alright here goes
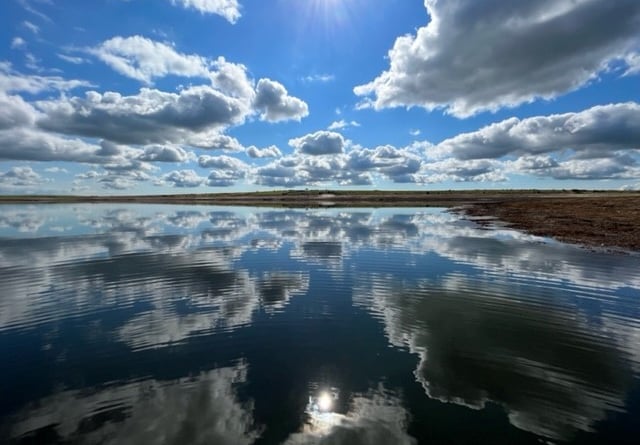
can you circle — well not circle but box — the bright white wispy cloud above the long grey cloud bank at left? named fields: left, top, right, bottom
left=89, top=35, right=209, bottom=84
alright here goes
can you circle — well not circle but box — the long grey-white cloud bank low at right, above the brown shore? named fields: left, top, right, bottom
left=422, top=102, right=640, bottom=182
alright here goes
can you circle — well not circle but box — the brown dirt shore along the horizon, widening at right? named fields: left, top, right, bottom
left=0, top=190, right=640, bottom=251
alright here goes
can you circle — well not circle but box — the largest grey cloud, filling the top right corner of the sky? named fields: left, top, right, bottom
left=354, top=0, right=640, bottom=117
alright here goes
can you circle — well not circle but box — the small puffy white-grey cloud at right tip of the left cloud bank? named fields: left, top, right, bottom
left=254, top=79, right=309, bottom=122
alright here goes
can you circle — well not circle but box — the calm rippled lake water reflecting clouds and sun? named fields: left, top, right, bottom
left=0, top=205, right=640, bottom=444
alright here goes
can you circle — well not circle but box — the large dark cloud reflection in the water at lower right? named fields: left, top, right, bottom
left=355, top=276, right=632, bottom=439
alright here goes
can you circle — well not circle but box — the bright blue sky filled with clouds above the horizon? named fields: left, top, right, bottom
left=0, top=0, right=640, bottom=194
